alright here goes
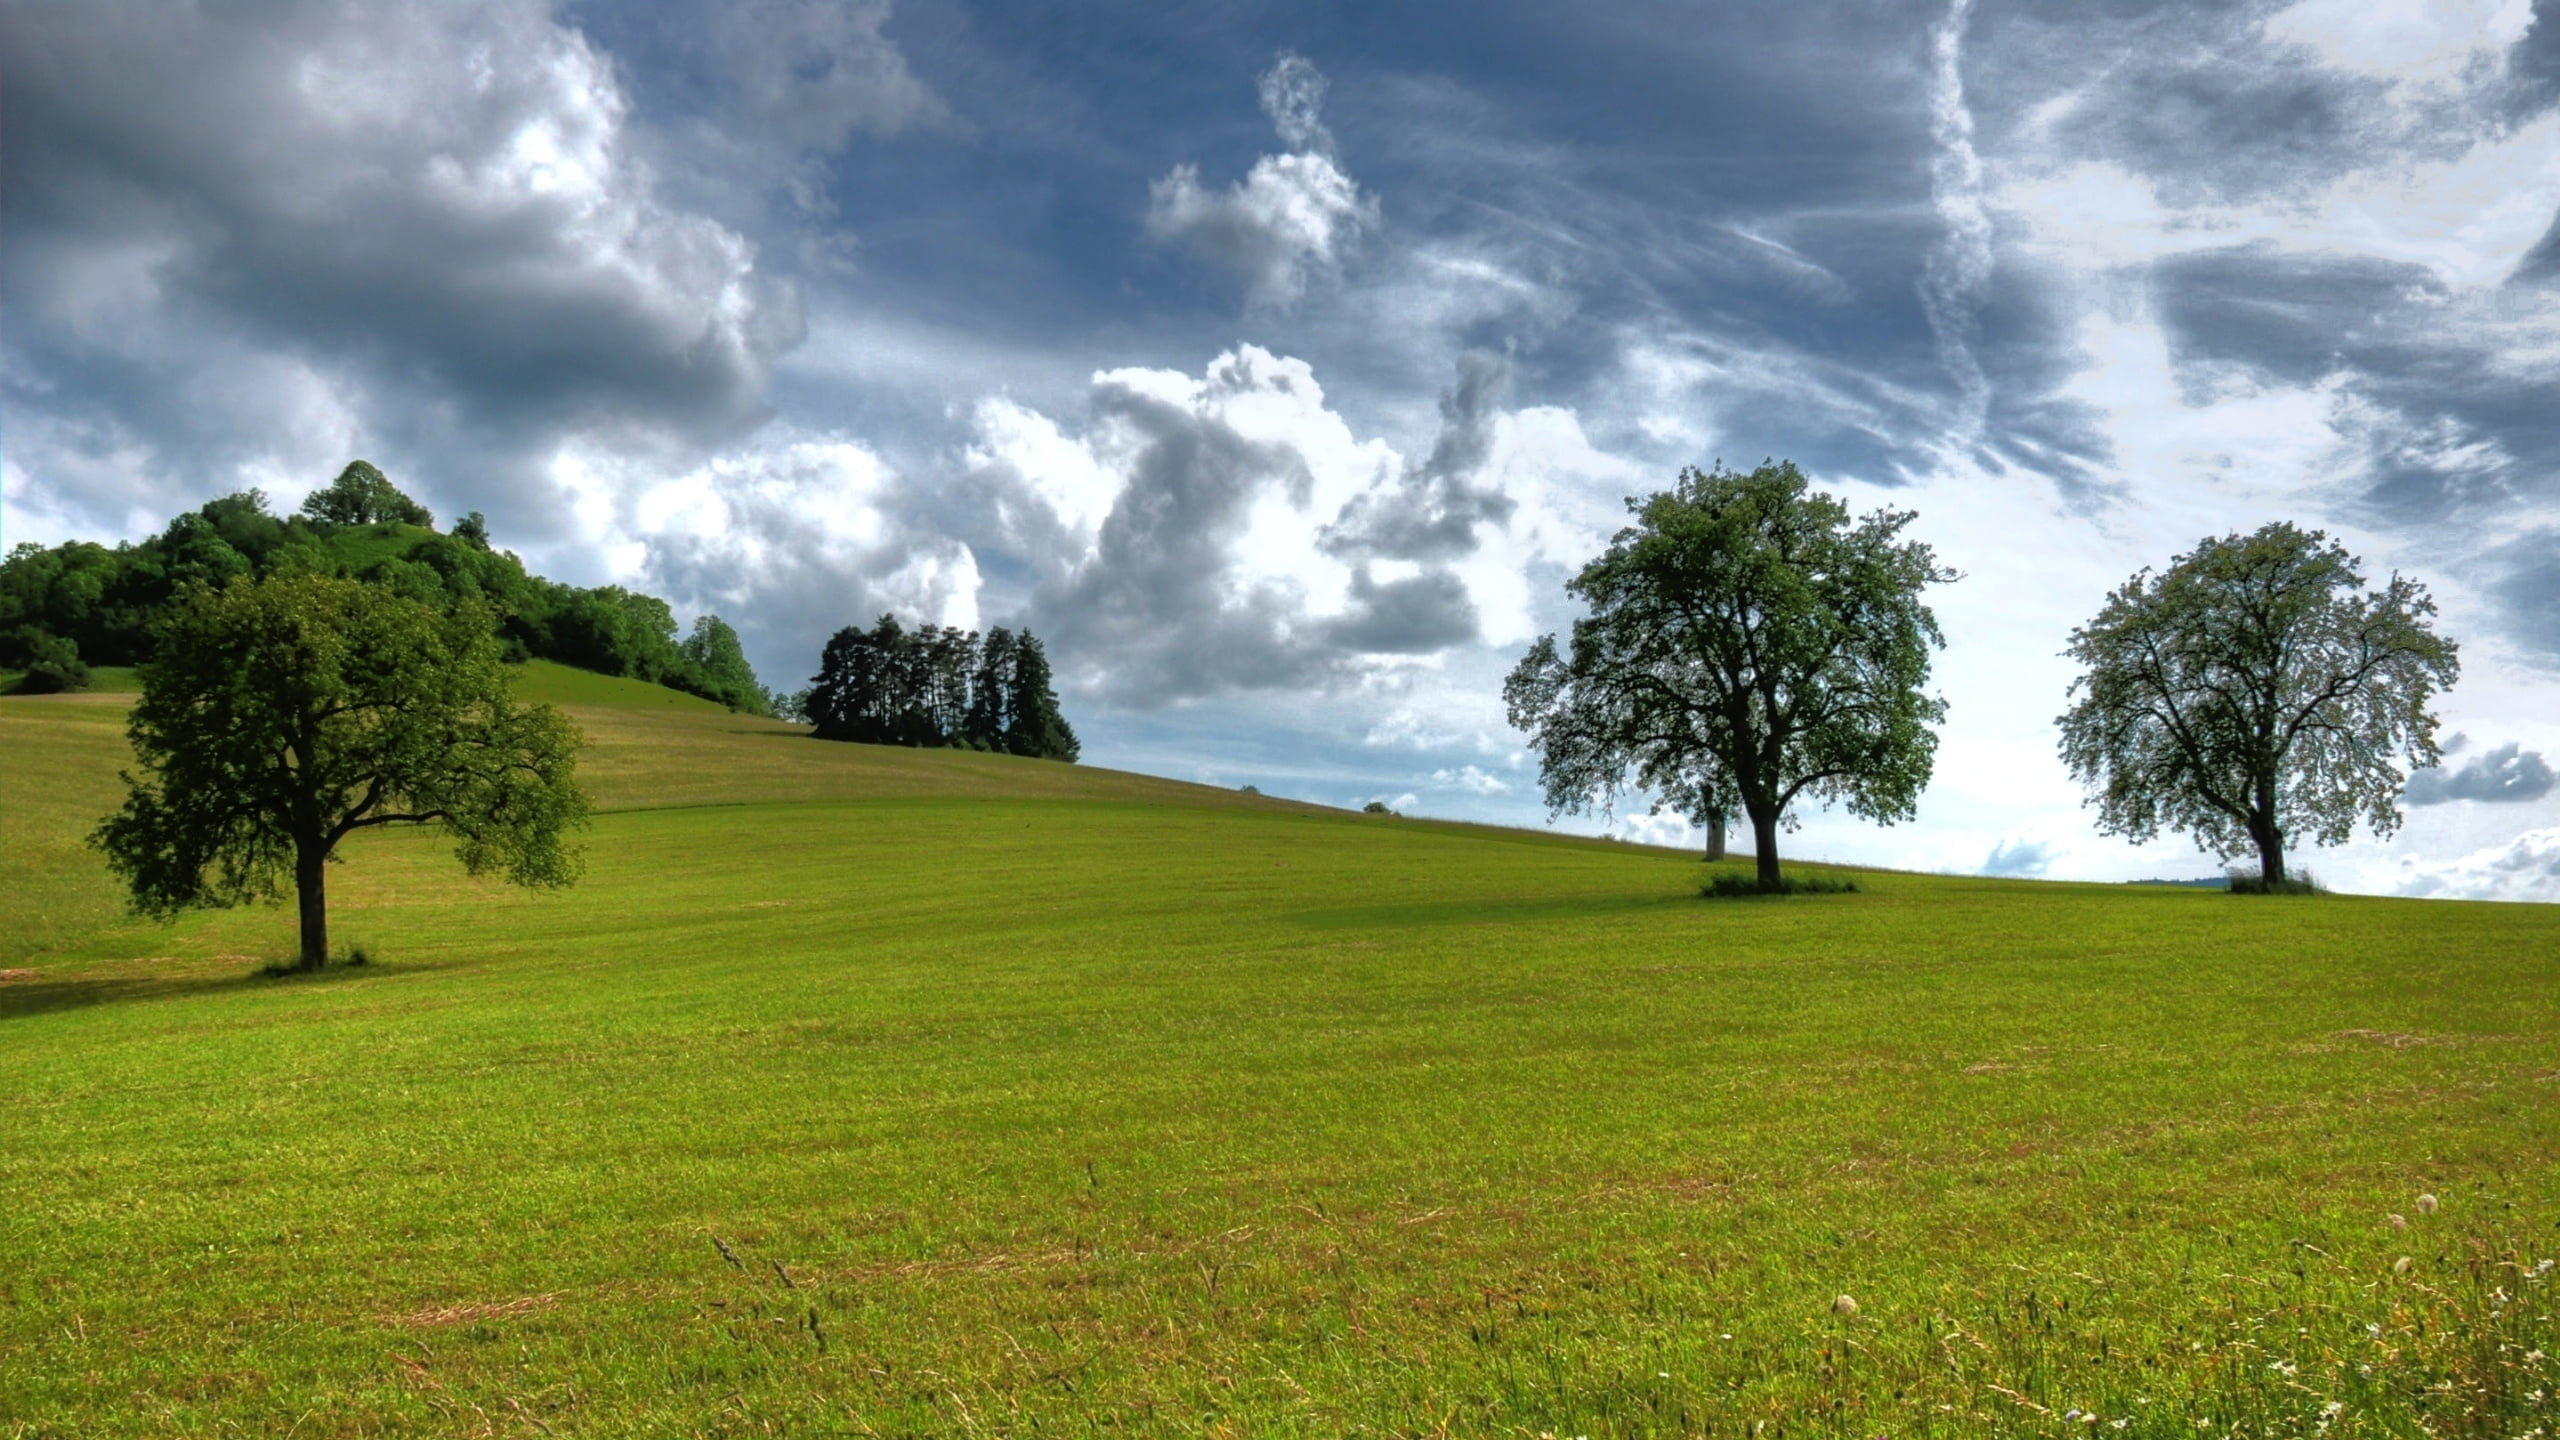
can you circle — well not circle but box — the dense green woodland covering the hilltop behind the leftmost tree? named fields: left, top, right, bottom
left=0, top=461, right=773, bottom=715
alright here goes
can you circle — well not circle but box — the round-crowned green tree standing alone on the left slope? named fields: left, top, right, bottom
left=90, top=574, right=586, bottom=969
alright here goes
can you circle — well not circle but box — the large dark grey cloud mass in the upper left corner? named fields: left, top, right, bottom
left=0, top=0, right=801, bottom=523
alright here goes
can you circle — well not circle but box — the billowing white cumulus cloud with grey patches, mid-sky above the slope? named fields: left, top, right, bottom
left=965, top=346, right=1626, bottom=707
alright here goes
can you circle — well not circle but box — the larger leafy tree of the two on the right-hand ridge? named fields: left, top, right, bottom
left=1503, top=464, right=1956, bottom=889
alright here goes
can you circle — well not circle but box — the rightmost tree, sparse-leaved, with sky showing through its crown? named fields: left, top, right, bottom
left=2061, top=520, right=2460, bottom=889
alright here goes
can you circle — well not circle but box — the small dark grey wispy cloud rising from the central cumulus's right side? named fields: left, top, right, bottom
left=1324, top=351, right=1518, bottom=561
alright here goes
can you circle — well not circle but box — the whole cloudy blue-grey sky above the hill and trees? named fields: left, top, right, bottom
left=0, top=0, right=2560, bottom=899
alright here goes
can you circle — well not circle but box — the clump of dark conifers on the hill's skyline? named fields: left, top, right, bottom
left=799, top=615, right=1078, bottom=761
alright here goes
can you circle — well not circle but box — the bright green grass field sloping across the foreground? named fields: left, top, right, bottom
left=0, top=666, right=2560, bottom=1437
